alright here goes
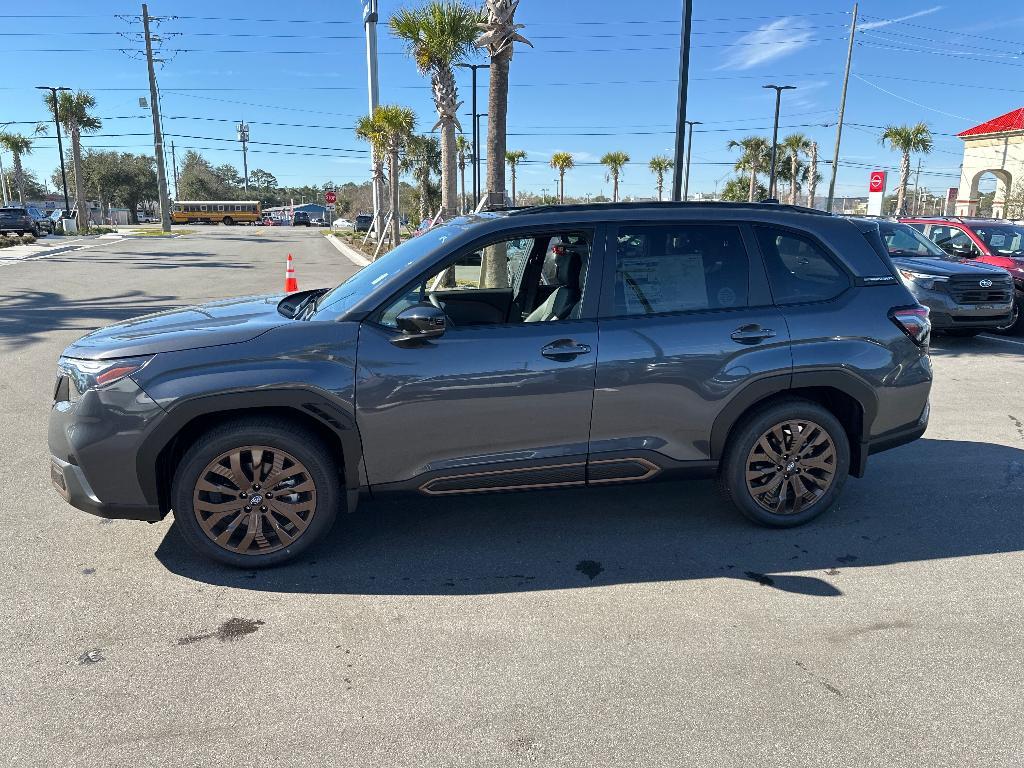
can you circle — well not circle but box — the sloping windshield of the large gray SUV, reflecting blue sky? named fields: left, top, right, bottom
left=314, top=220, right=469, bottom=319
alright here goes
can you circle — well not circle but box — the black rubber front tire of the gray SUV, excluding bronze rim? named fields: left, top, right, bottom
left=171, top=418, right=343, bottom=568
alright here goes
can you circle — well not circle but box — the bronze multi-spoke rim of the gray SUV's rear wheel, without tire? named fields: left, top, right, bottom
left=746, top=419, right=836, bottom=515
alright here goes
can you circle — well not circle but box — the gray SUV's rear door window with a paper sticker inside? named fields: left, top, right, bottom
left=612, top=224, right=750, bottom=315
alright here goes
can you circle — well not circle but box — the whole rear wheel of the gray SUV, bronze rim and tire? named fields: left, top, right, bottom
left=719, top=397, right=850, bottom=527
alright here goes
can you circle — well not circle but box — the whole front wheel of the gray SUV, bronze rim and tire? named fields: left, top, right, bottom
left=171, top=419, right=341, bottom=568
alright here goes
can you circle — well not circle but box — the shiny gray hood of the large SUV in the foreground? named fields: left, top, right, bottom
left=65, top=294, right=295, bottom=359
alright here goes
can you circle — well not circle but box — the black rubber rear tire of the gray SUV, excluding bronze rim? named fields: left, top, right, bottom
left=718, top=397, right=850, bottom=527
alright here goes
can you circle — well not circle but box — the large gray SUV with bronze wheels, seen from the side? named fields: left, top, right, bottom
left=49, top=203, right=932, bottom=567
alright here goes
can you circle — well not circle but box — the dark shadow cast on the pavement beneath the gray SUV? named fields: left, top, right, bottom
left=156, top=442, right=1024, bottom=597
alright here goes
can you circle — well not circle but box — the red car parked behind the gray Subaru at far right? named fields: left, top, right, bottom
left=900, top=216, right=1024, bottom=334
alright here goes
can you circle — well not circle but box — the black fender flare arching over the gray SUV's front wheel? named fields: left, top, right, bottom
left=136, top=387, right=362, bottom=505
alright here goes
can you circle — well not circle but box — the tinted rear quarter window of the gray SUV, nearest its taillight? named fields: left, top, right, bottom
left=755, top=226, right=850, bottom=304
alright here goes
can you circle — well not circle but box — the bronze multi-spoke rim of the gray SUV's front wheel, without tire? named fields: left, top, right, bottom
left=193, top=445, right=316, bottom=555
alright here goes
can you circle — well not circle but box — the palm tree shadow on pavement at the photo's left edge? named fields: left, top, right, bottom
left=0, top=291, right=183, bottom=347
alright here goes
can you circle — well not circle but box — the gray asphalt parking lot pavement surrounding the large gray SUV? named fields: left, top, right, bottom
left=0, top=227, right=1024, bottom=766
